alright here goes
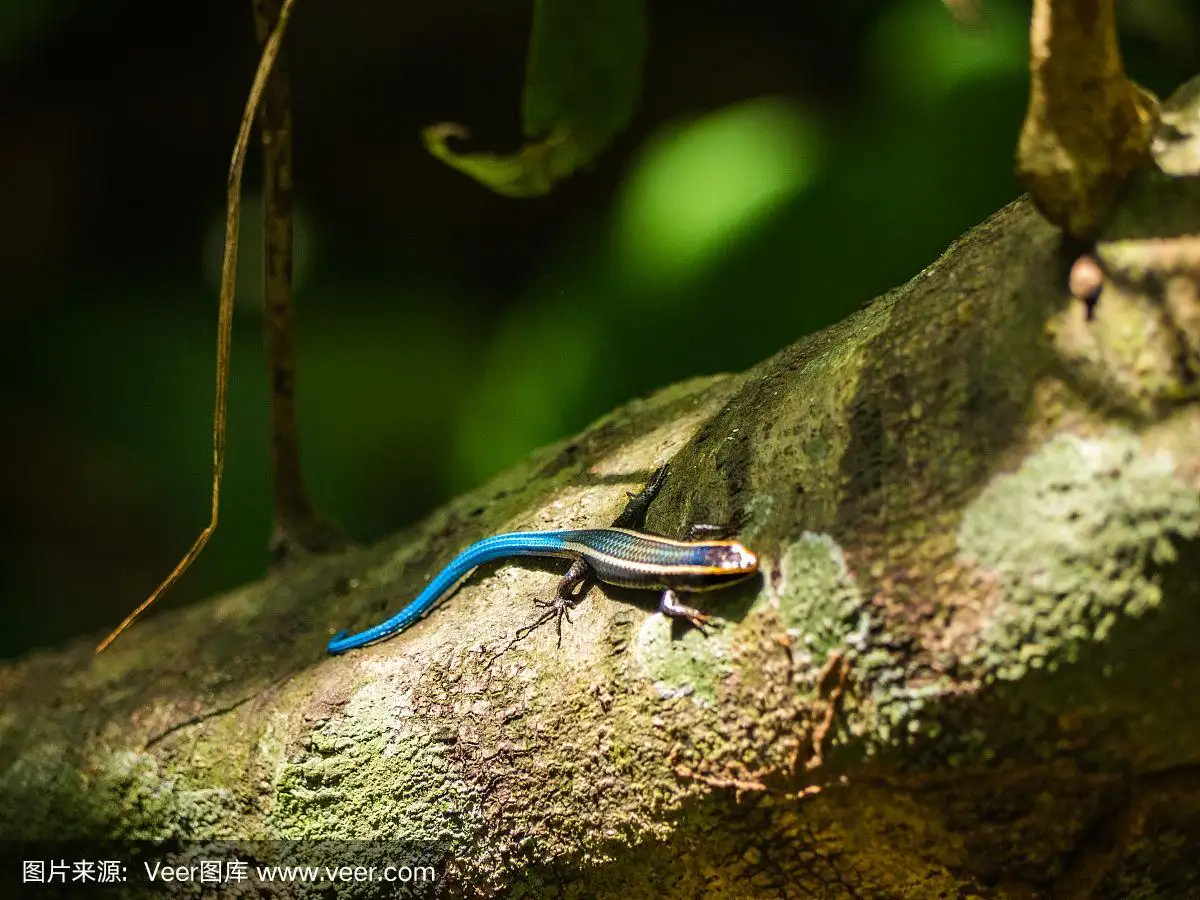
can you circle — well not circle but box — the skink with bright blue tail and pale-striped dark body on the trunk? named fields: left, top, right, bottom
left=329, top=466, right=758, bottom=653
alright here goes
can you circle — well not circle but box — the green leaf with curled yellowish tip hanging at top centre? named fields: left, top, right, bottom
left=421, top=0, right=646, bottom=197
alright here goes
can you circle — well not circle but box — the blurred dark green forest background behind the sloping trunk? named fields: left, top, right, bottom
left=0, top=0, right=1200, bottom=655
